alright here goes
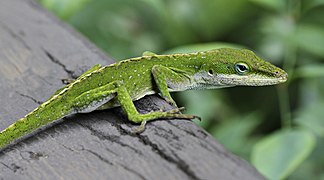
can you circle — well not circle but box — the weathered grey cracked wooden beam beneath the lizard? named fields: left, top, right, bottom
left=0, top=0, right=263, bottom=180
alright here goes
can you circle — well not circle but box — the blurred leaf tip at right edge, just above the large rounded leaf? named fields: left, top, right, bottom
left=295, top=102, right=324, bottom=137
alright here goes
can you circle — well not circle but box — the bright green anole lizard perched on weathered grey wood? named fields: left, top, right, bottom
left=0, top=48, right=287, bottom=149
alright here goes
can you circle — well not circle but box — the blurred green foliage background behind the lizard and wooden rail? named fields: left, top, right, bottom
left=39, top=0, right=324, bottom=179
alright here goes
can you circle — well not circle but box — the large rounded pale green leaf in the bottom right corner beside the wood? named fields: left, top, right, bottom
left=251, top=129, right=315, bottom=179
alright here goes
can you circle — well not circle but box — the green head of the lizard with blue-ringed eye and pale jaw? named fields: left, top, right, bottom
left=197, top=48, right=288, bottom=88
